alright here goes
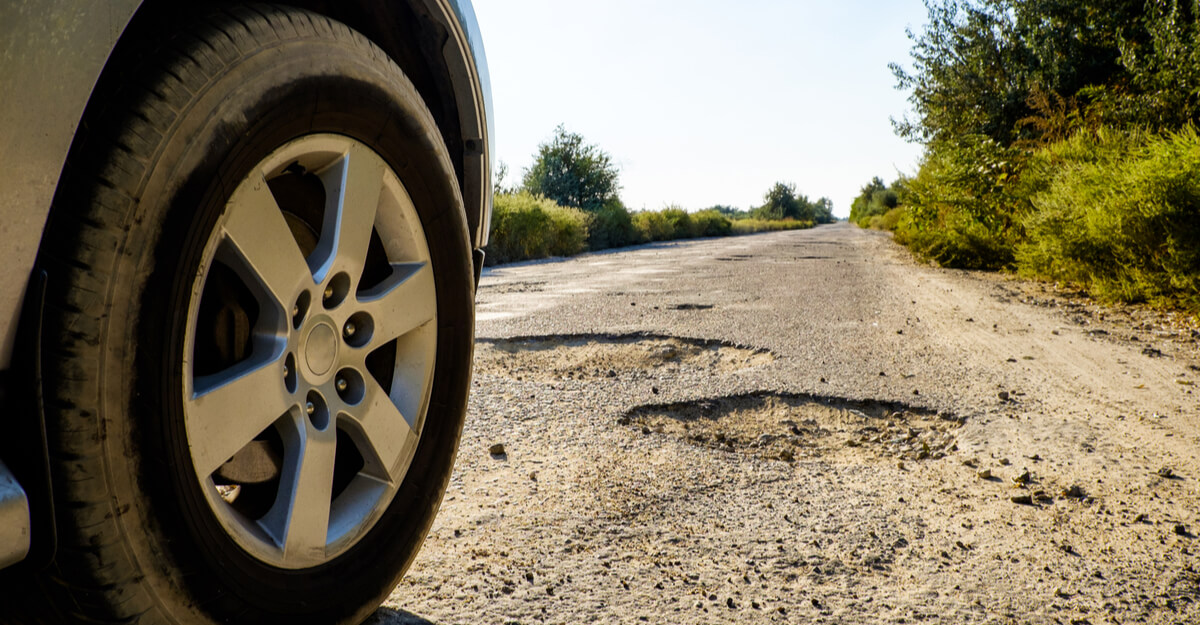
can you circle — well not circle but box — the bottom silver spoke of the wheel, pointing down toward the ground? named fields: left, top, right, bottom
left=263, top=414, right=337, bottom=566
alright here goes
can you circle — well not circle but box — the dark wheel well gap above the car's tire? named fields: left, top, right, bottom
left=109, top=0, right=474, bottom=197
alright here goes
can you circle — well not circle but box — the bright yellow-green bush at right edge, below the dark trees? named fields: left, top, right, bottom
left=1016, top=128, right=1200, bottom=310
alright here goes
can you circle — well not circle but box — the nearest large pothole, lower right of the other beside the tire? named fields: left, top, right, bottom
left=619, top=392, right=962, bottom=462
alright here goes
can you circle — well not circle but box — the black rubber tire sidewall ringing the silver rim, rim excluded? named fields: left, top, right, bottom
left=101, top=28, right=473, bottom=623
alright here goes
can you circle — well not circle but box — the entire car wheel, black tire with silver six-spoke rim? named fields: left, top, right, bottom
left=25, top=5, right=474, bottom=624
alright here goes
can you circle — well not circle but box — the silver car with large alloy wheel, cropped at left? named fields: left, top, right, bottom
left=0, top=0, right=492, bottom=624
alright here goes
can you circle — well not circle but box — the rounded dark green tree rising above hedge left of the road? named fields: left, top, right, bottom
left=523, top=125, right=620, bottom=212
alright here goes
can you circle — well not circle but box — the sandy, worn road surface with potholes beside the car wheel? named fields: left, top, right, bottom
left=371, top=226, right=1200, bottom=625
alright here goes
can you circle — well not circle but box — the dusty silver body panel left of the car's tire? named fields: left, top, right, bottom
left=0, top=0, right=139, bottom=369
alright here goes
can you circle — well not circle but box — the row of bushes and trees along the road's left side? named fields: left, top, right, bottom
left=486, top=126, right=834, bottom=264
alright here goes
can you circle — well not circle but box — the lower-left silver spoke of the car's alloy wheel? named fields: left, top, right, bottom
left=184, top=357, right=295, bottom=477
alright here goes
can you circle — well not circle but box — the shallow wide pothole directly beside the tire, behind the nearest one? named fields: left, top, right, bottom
left=475, top=333, right=775, bottom=380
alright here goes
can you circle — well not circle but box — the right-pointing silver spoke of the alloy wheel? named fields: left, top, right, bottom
left=359, top=263, right=438, bottom=348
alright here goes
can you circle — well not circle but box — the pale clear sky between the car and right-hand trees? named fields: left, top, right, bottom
left=474, top=0, right=925, bottom=216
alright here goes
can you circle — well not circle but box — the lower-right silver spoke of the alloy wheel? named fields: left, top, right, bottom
left=343, top=379, right=418, bottom=482
